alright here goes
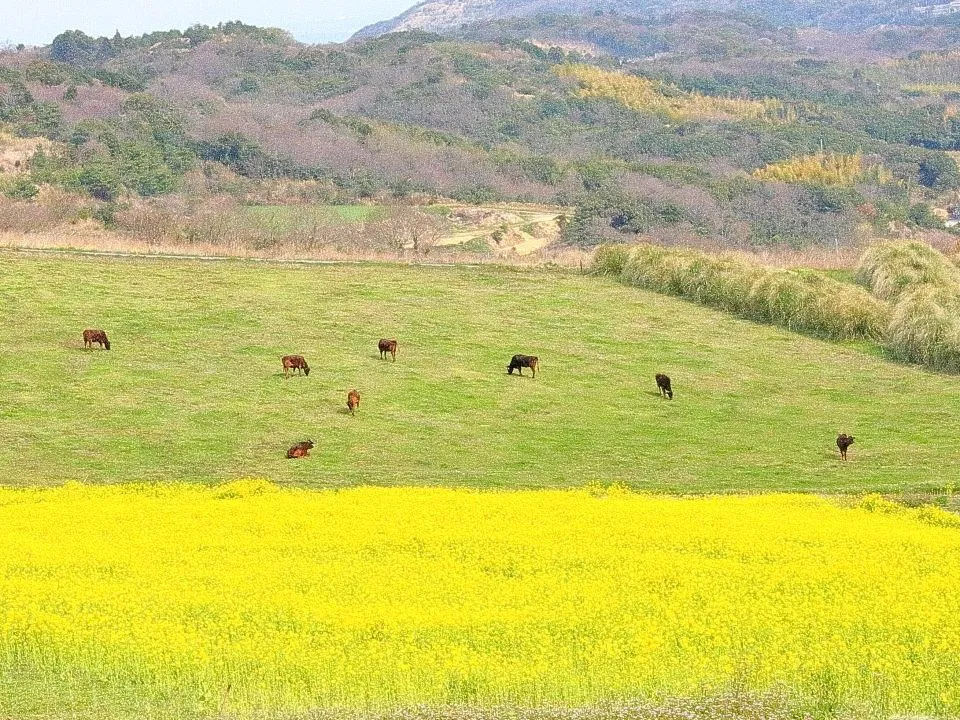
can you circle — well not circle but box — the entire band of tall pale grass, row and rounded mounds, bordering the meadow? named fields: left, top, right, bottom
left=604, top=241, right=960, bottom=373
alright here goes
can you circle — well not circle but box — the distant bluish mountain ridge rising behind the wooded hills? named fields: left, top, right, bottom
left=354, top=0, right=960, bottom=39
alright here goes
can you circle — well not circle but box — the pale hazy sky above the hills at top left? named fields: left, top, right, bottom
left=0, top=0, right=417, bottom=45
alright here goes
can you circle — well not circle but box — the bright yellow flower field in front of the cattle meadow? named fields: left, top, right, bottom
left=0, top=480, right=960, bottom=717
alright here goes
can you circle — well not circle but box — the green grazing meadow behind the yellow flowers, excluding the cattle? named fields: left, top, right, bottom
left=0, top=253, right=960, bottom=493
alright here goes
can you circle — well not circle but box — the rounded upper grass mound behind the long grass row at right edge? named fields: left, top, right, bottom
left=855, top=241, right=960, bottom=302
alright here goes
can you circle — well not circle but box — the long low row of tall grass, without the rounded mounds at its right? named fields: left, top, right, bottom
left=593, top=245, right=889, bottom=339
